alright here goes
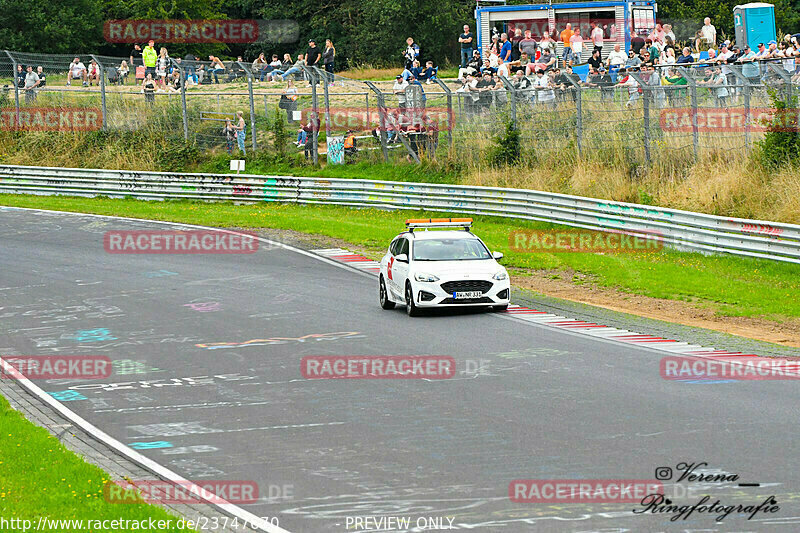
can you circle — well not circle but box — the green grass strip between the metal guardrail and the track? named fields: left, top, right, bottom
left=0, top=195, right=800, bottom=322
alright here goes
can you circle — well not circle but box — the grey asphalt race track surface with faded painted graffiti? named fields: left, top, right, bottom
left=0, top=208, right=800, bottom=532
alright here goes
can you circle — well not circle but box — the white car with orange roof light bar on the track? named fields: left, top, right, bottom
left=379, top=218, right=511, bottom=316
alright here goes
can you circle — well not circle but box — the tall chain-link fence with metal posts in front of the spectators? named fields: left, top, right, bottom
left=0, top=51, right=799, bottom=164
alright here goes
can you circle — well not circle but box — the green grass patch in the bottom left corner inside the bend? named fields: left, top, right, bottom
left=0, top=390, right=187, bottom=532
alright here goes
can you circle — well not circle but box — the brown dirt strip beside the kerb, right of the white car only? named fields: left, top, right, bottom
left=511, top=271, right=800, bottom=348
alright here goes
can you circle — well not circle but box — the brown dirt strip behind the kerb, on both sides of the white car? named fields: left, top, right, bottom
left=245, top=229, right=800, bottom=348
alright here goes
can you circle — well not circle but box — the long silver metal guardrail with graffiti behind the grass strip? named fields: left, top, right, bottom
left=0, top=165, right=800, bottom=263
